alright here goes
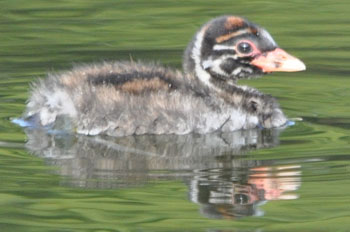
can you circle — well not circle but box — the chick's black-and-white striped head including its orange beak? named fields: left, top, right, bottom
left=183, top=16, right=305, bottom=86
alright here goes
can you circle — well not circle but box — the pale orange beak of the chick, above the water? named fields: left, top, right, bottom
left=250, top=48, right=306, bottom=72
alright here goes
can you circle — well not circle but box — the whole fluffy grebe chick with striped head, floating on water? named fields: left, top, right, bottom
left=24, top=16, right=305, bottom=136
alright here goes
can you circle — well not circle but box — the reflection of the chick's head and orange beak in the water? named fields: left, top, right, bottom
left=190, top=161, right=301, bottom=219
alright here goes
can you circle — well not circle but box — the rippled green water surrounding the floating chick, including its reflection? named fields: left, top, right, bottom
left=0, top=0, right=350, bottom=232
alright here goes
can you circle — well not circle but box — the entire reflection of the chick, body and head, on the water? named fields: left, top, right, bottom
left=26, top=130, right=300, bottom=219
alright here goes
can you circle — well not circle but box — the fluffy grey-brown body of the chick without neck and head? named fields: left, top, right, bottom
left=26, top=62, right=241, bottom=136
